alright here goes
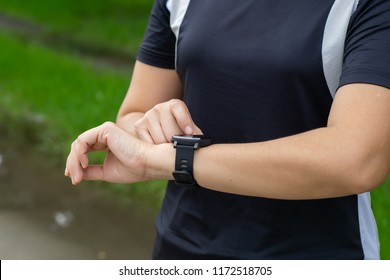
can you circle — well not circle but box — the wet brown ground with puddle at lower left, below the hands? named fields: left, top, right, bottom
left=0, top=138, right=157, bottom=259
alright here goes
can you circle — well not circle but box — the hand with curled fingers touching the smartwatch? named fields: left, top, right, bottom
left=135, top=99, right=203, bottom=144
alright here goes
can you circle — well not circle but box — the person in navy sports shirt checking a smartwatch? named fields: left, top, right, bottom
left=65, top=0, right=390, bottom=259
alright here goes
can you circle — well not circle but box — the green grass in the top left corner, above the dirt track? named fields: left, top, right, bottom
left=0, top=0, right=153, bottom=55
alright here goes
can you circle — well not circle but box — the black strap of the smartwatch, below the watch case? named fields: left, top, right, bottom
left=172, top=144, right=196, bottom=186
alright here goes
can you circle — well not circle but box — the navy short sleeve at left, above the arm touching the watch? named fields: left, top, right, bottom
left=137, top=0, right=176, bottom=69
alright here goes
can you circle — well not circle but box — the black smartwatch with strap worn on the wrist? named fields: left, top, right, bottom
left=171, top=135, right=211, bottom=186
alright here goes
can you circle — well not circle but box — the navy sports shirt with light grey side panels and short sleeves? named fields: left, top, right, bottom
left=138, top=0, right=390, bottom=259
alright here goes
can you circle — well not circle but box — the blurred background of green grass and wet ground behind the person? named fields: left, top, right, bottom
left=0, top=0, right=390, bottom=259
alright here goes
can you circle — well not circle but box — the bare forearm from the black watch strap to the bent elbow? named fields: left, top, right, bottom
left=194, top=128, right=387, bottom=199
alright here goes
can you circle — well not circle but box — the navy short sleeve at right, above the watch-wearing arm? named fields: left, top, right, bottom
left=340, top=0, right=390, bottom=88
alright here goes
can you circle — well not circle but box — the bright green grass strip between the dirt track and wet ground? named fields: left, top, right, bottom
left=0, top=31, right=125, bottom=137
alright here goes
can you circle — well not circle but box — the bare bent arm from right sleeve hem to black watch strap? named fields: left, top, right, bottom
left=194, top=84, right=390, bottom=199
